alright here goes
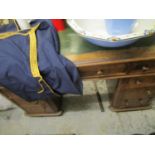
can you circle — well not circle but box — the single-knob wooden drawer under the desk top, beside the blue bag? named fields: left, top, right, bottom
left=79, top=64, right=126, bottom=78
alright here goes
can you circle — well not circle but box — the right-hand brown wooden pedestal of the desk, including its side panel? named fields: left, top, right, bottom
left=107, top=78, right=155, bottom=112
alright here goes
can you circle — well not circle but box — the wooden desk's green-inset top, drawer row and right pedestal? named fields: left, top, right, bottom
left=59, top=29, right=155, bottom=111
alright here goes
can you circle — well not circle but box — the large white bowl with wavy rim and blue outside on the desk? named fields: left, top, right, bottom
left=67, top=19, right=155, bottom=47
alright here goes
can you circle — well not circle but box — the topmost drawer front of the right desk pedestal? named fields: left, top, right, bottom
left=120, top=76, right=155, bottom=90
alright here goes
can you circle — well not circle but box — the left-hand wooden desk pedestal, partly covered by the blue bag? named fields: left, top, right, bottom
left=0, top=87, right=62, bottom=117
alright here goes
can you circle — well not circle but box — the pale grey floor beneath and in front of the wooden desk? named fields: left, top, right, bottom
left=0, top=80, right=155, bottom=135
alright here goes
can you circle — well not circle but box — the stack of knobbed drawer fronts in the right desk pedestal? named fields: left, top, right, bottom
left=111, top=77, right=155, bottom=109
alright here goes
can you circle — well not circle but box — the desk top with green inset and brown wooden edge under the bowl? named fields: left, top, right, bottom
left=59, top=28, right=155, bottom=66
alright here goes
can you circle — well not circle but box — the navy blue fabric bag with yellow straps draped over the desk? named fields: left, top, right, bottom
left=0, top=20, right=82, bottom=101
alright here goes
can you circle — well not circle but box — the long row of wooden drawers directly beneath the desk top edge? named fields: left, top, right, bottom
left=79, top=61, right=155, bottom=79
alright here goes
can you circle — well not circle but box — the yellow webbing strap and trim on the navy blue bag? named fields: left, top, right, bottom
left=0, top=25, right=59, bottom=96
